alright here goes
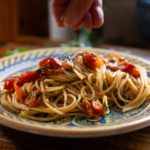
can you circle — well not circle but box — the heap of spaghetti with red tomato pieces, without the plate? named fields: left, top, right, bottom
left=0, top=51, right=150, bottom=121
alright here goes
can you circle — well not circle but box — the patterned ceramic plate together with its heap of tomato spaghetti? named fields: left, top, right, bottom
left=0, top=48, right=150, bottom=137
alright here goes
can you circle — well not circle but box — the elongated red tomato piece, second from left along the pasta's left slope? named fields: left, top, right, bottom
left=20, top=71, right=40, bottom=85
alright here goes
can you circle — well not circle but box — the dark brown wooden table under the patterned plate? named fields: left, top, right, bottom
left=0, top=44, right=150, bottom=150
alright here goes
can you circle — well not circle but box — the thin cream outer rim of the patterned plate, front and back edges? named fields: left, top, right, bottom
left=0, top=47, right=150, bottom=137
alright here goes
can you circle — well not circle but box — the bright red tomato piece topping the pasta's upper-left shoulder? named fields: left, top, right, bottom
left=39, top=57, right=62, bottom=69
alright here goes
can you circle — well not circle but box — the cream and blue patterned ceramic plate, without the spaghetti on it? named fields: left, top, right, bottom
left=0, top=48, right=150, bottom=137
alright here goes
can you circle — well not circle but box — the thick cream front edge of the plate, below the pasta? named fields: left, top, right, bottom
left=0, top=114, right=150, bottom=138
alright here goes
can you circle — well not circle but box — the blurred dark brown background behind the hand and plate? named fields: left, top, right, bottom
left=0, top=0, right=150, bottom=55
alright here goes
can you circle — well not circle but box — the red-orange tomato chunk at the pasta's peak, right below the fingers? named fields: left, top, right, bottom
left=83, top=53, right=104, bottom=70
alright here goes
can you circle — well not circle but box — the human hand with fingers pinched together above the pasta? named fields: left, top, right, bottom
left=51, top=0, right=104, bottom=29
